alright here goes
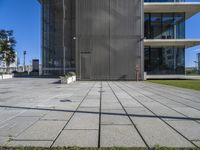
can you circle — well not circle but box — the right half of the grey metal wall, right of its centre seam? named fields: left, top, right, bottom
left=110, top=0, right=141, bottom=80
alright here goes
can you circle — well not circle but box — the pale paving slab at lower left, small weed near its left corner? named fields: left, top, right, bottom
left=14, top=121, right=66, bottom=141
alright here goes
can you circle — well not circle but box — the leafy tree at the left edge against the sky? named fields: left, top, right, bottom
left=0, top=30, right=16, bottom=72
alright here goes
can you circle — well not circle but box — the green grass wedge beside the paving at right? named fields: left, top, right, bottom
left=148, top=80, right=200, bottom=91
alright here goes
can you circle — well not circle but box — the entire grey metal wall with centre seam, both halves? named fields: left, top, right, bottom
left=76, top=0, right=143, bottom=80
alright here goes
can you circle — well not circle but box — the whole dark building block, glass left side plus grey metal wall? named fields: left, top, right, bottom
left=42, top=0, right=143, bottom=80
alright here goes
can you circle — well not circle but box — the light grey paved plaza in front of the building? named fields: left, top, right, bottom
left=0, top=78, right=200, bottom=147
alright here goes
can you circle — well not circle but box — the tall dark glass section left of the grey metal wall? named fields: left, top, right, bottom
left=42, top=0, right=75, bottom=75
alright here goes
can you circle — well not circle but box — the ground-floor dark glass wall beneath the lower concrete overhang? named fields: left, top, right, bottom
left=145, top=47, right=185, bottom=75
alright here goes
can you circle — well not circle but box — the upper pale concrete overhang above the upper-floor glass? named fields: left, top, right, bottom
left=144, top=2, right=200, bottom=19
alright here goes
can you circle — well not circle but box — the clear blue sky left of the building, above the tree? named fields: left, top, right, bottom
left=0, top=0, right=41, bottom=64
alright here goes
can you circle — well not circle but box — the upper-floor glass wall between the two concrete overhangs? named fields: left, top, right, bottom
left=144, top=13, right=185, bottom=39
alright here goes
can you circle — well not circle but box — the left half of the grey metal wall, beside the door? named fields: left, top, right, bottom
left=76, top=0, right=109, bottom=80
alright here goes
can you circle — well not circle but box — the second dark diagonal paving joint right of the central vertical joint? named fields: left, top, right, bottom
left=114, top=83, right=199, bottom=148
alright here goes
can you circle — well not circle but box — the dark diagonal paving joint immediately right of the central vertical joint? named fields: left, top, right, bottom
left=107, top=82, right=150, bottom=150
